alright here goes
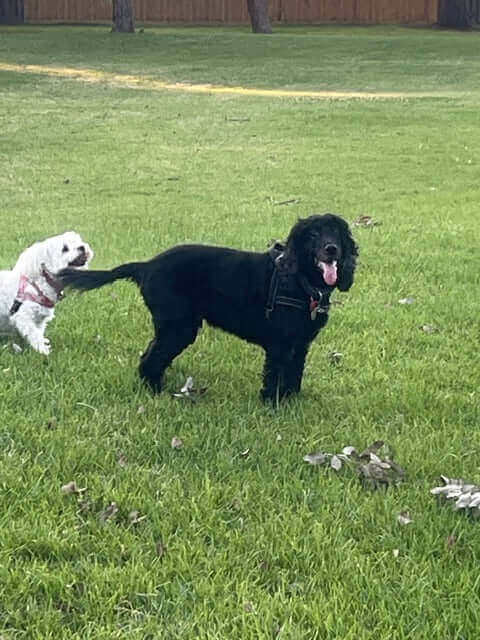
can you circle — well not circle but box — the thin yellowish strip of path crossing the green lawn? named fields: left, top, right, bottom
left=0, top=62, right=461, bottom=100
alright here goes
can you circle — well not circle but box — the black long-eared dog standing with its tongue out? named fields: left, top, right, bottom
left=58, top=214, right=358, bottom=401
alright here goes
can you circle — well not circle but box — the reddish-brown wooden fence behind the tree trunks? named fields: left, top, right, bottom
left=25, top=0, right=438, bottom=24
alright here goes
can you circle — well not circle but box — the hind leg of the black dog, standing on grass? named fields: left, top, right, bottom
left=139, top=325, right=198, bottom=393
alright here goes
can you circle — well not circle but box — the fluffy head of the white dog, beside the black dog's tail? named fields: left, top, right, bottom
left=14, top=231, right=93, bottom=276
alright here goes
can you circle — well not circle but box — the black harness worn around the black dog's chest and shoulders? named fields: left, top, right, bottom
left=265, top=242, right=330, bottom=321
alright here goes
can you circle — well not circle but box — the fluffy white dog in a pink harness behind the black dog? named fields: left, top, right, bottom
left=0, top=231, right=93, bottom=355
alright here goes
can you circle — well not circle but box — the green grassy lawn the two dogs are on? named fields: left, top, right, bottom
left=0, top=27, right=480, bottom=640
